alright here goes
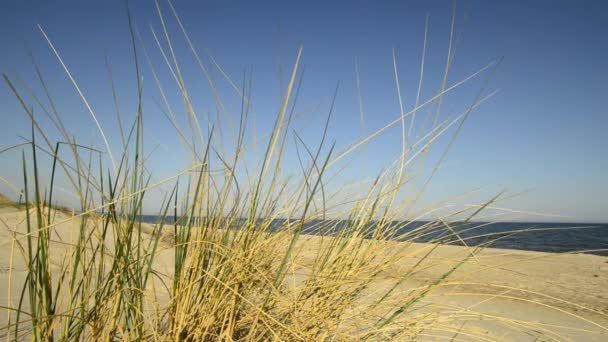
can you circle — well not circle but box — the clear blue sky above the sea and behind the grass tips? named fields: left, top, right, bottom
left=0, top=0, right=608, bottom=222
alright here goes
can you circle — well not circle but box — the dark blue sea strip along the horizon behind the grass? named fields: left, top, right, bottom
left=141, top=215, right=608, bottom=256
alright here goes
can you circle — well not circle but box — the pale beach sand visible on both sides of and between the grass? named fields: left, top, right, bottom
left=0, top=207, right=608, bottom=341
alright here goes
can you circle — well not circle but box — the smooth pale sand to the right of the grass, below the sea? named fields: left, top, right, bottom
left=294, top=236, right=608, bottom=341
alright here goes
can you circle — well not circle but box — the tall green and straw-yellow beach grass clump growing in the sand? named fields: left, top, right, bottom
left=0, top=3, right=604, bottom=341
